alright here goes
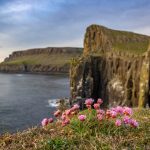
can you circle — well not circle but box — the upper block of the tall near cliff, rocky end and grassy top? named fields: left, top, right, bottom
left=84, top=25, right=150, bottom=54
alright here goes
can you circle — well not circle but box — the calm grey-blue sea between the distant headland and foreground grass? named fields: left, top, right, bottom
left=0, top=74, right=69, bottom=134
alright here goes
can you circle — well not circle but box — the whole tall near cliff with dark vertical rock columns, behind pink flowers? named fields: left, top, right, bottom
left=70, top=25, right=150, bottom=107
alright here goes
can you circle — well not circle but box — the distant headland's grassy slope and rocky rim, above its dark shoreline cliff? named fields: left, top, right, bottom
left=2, top=47, right=82, bottom=66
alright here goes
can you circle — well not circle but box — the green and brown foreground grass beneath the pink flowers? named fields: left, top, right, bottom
left=0, top=109, right=150, bottom=150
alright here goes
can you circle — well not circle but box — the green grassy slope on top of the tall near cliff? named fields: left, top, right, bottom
left=89, top=25, right=150, bottom=54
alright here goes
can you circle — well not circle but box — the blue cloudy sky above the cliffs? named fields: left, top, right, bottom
left=0, top=0, right=150, bottom=61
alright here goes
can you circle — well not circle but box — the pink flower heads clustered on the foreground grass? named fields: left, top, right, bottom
left=41, top=98, right=139, bottom=128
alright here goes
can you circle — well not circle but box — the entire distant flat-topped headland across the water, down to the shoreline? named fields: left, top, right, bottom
left=0, top=47, right=82, bottom=73
